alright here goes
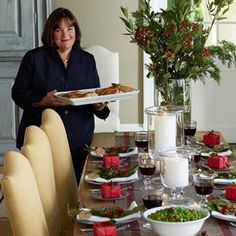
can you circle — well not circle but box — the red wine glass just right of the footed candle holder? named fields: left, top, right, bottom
left=193, top=172, right=214, bottom=207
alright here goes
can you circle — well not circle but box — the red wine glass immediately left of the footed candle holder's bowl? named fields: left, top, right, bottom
left=138, top=152, right=156, bottom=185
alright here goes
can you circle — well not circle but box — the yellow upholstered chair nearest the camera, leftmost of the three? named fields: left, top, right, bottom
left=1, top=151, right=50, bottom=236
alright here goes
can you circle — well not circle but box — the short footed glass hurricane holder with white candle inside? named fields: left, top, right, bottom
left=159, top=147, right=195, bottom=205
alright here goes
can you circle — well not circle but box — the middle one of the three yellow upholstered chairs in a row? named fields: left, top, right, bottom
left=21, top=125, right=62, bottom=236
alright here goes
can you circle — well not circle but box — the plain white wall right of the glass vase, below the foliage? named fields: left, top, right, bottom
left=192, top=68, right=236, bottom=143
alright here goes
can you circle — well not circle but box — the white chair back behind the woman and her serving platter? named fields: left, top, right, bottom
left=84, top=45, right=120, bottom=133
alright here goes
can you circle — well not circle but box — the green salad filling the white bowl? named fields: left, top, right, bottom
left=148, top=207, right=206, bottom=222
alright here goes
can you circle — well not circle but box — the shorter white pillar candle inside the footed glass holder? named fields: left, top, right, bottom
left=165, top=157, right=189, bottom=188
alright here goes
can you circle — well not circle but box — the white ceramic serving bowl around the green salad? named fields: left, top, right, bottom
left=143, top=206, right=210, bottom=236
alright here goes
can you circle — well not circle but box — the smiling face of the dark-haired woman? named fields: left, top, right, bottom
left=53, top=19, right=75, bottom=52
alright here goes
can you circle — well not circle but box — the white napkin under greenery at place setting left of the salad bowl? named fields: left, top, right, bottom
left=76, top=201, right=141, bottom=223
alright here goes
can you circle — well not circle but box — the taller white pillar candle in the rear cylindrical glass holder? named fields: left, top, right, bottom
left=154, top=113, right=177, bottom=153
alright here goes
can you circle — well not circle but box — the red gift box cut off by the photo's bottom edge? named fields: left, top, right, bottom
left=93, top=222, right=117, bottom=236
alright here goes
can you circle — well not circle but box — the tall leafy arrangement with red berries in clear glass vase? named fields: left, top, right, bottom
left=120, top=0, right=236, bottom=118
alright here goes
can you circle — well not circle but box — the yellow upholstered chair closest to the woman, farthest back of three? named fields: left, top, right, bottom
left=41, top=109, right=79, bottom=229
